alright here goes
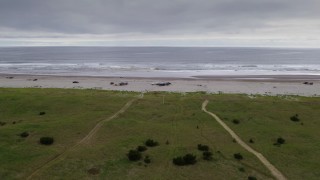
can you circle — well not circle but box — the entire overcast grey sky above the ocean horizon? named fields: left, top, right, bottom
left=0, top=0, right=320, bottom=47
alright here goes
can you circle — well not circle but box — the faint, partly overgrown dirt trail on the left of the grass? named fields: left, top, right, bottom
left=26, top=94, right=143, bottom=180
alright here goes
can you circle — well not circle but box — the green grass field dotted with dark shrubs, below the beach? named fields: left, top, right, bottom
left=0, top=88, right=320, bottom=180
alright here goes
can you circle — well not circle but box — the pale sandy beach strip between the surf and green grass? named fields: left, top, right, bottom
left=0, top=74, right=320, bottom=96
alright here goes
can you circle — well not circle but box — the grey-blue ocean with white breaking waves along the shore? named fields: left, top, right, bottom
left=0, top=47, right=320, bottom=78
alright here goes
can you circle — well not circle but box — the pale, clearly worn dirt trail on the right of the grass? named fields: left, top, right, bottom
left=202, top=100, right=287, bottom=180
